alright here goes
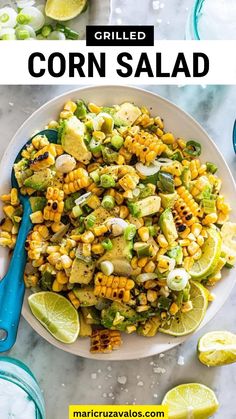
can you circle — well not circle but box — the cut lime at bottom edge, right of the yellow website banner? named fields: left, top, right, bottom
left=162, top=383, right=219, bottom=419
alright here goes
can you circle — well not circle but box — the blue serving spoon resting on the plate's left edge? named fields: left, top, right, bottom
left=0, top=129, right=58, bottom=352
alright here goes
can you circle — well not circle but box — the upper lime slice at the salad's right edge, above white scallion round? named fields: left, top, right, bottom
left=188, top=228, right=222, bottom=281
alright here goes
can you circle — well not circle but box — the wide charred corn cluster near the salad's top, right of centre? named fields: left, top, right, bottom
left=124, top=130, right=167, bottom=164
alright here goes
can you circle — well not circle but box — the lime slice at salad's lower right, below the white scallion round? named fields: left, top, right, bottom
left=159, top=281, right=208, bottom=336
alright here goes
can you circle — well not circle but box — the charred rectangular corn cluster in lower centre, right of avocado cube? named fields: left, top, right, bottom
left=94, top=272, right=135, bottom=303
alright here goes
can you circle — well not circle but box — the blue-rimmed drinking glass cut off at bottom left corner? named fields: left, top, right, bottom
left=0, top=357, right=46, bottom=419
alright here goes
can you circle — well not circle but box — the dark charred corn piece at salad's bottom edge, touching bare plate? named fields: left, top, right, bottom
left=90, top=329, right=122, bottom=354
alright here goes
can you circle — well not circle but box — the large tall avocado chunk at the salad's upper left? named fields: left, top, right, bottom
left=61, top=116, right=92, bottom=164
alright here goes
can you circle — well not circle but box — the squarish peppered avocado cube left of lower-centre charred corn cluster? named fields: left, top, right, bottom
left=69, top=258, right=95, bottom=284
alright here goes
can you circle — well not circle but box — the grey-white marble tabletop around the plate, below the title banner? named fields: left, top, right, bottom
left=0, top=86, right=236, bottom=419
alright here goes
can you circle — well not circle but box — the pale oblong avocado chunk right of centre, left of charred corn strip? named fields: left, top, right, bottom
left=128, top=196, right=161, bottom=217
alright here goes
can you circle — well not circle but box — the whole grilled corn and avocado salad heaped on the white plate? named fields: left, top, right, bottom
left=0, top=100, right=236, bottom=353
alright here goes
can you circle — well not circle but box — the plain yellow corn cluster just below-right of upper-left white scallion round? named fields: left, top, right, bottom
left=63, top=167, right=91, bottom=195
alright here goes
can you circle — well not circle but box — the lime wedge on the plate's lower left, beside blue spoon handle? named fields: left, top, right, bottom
left=28, top=291, right=79, bottom=343
